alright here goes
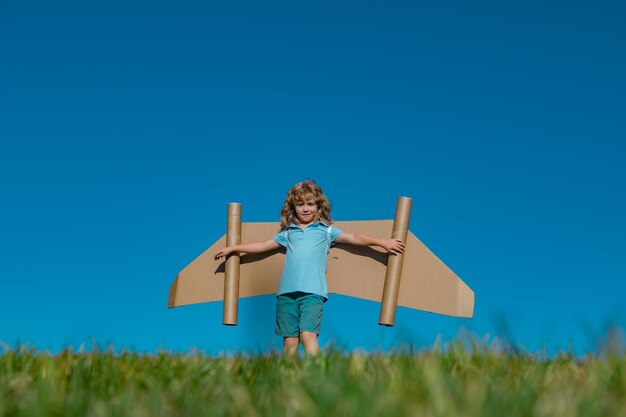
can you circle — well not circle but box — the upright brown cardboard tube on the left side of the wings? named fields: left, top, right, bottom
left=222, top=203, right=241, bottom=326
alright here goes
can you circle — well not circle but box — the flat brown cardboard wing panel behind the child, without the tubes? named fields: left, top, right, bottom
left=168, top=220, right=474, bottom=317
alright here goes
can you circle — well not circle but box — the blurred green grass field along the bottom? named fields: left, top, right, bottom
left=0, top=343, right=626, bottom=417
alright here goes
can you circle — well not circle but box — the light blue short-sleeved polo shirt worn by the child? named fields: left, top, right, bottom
left=274, top=221, right=342, bottom=298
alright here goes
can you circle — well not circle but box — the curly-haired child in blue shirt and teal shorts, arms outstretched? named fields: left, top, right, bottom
left=215, top=180, right=404, bottom=355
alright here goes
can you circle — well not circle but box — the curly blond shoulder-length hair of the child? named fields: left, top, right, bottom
left=280, top=179, right=333, bottom=230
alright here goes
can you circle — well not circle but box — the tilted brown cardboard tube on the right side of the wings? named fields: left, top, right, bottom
left=378, top=197, right=411, bottom=326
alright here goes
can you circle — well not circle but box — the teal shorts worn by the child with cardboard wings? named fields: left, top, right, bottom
left=274, top=292, right=326, bottom=337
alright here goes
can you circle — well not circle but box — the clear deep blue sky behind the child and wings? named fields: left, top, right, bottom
left=0, top=0, right=626, bottom=352
